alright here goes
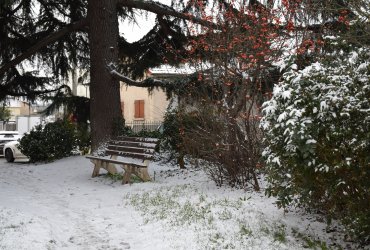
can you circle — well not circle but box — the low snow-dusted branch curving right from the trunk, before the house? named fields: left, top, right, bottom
left=107, top=63, right=173, bottom=88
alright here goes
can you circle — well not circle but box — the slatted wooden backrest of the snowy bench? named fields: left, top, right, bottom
left=105, top=136, right=158, bottom=160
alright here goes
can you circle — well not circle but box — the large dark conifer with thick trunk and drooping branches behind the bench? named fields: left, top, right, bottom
left=0, top=0, right=206, bottom=148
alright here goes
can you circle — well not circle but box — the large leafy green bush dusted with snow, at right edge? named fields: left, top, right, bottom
left=261, top=40, right=370, bottom=244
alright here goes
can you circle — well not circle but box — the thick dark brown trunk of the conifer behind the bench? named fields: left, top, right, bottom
left=87, top=0, right=122, bottom=150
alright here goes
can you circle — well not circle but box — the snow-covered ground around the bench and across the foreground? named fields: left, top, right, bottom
left=0, top=156, right=362, bottom=250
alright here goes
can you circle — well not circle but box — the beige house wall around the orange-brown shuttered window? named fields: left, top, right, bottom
left=121, top=84, right=169, bottom=122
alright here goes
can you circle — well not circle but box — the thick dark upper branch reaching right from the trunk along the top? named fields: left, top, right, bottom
left=117, top=0, right=218, bottom=28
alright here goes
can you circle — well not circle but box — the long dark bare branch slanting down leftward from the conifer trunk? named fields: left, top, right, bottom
left=0, top=19, right=88, bottom=76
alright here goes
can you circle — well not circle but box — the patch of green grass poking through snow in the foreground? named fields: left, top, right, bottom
left=125, top=184, right=328, bottom=250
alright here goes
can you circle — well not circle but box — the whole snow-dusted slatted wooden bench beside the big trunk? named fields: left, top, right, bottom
left=86, top=136, right=158, bottom=184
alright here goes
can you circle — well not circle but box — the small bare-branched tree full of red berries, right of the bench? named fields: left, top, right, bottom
left=165, top=1, right=285, bottom=190
